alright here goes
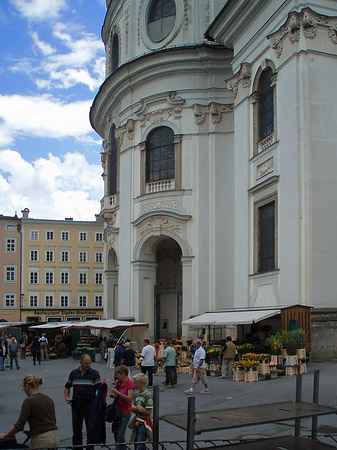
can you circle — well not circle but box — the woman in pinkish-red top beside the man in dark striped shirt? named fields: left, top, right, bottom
left=109, top=366, right=135, bottom=450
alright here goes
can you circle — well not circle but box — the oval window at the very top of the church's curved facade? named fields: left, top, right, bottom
left=147, top=0, right=176, bottom=42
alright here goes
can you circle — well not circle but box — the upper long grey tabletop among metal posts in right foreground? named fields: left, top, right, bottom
left=162, top=402, right=337, bottom=434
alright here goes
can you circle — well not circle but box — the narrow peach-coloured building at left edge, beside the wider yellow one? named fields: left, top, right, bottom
left=0, top=214, right=21, bottom=322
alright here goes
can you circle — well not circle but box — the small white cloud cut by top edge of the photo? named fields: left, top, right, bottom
left=11, top=0, right=67, bottom=21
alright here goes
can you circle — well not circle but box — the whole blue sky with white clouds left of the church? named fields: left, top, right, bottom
left=0, top=0, right=106, bottom=220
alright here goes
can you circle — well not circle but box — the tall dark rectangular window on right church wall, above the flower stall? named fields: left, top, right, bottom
left=258, top=201, right=276, bottom=273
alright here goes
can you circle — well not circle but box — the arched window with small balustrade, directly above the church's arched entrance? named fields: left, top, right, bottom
left=146, top=127, right=174, bottom=183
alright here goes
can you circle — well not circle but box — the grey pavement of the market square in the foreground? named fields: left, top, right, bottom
left=0, top=357, right=337, bottom=445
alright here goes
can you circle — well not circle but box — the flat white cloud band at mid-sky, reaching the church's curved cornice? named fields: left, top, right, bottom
left=0, top=94, right=92, bottom=147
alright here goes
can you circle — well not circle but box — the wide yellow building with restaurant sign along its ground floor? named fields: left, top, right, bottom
left=21, top=208, right=103, bottom=322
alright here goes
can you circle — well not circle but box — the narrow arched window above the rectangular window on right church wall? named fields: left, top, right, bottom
left=258, top=67, right=274, bottom=141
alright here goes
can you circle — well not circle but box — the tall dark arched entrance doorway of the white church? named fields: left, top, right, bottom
left=154, top=238, right=183, bottom=340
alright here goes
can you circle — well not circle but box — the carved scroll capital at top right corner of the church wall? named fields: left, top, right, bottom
left=267, top=8, right=337, bottom=58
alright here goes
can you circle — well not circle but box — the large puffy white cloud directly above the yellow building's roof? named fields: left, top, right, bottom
left=0, top=149, right=103, bottom=220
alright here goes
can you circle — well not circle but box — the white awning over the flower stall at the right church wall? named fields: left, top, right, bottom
left=182, top=309, right=281, bottom=326
